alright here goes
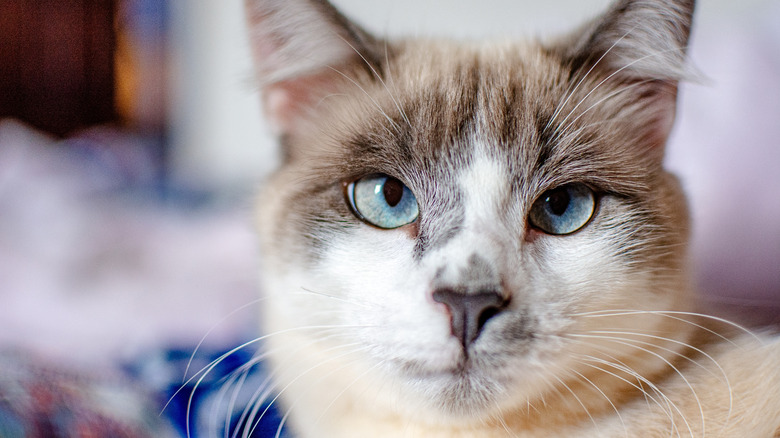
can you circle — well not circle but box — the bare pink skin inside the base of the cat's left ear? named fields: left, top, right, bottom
left=263, top=69, right=339, bottom=134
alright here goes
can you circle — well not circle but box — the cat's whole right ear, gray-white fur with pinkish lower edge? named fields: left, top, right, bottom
left=553, top=0, right=694, bottom=145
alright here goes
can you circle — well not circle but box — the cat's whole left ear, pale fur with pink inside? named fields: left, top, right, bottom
left=245, top=0, right=379, bottom=135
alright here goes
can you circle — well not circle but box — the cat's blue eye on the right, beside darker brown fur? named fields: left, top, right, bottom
left=528, top=184, right=596, bottom=235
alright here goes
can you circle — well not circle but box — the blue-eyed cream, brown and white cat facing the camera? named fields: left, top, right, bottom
left=241, top=0, right=780, bottom=438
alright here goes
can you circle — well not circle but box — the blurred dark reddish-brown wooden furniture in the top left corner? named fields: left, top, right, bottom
left=0, top=0, right=116, bottom=135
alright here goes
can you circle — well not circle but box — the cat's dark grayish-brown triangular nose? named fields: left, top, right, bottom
left=433, top=288, right=509, bottom=348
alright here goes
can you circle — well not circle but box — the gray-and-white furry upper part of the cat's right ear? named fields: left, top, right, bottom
left=563, top=0, right=694, bottom=82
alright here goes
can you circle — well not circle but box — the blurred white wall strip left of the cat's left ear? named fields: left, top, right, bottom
left=170, top=0, right=275, bottom=191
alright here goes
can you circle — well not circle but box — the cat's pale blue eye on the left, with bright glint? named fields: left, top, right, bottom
left=347, top=174, right=420, bottom=229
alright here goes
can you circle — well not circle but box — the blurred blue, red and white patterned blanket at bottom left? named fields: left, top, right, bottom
left=0, top=348, right=288, bottom=438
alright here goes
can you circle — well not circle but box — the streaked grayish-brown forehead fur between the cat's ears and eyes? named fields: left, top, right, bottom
left=298, top=39, right=663, bottom=200
